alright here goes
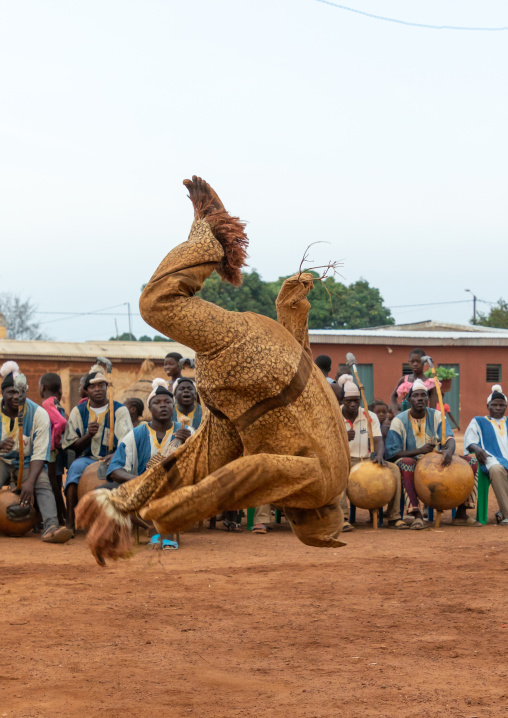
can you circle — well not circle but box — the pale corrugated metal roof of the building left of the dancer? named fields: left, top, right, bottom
left=0, top=339, right=195, bottom=361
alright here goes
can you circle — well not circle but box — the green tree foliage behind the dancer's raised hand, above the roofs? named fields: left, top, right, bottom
left=199, top=270, right=394, bottom=329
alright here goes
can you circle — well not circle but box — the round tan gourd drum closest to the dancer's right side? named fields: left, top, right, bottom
left=347, top=461, right=397, bottom=509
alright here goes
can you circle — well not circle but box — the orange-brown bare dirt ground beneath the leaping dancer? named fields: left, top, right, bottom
left=0, top=495, right=508, bottom=718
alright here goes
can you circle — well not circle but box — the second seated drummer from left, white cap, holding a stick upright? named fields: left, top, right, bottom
left=62, top=367, right=132, bottom=531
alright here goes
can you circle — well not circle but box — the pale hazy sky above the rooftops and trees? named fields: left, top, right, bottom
left=0, top=0, right=508, bottom=341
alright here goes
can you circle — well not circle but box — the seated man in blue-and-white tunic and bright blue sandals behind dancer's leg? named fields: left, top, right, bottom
left=106, top=379, right=191, bottom=549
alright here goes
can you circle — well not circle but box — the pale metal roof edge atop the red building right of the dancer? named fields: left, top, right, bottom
left=309, top=329, right=508, bottom=347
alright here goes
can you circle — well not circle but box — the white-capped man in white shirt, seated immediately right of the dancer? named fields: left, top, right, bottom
left=341, top=381, right=408, bottom=531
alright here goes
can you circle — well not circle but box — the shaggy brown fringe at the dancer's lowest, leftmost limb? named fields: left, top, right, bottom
left=76, top=489, right=133, bottom=566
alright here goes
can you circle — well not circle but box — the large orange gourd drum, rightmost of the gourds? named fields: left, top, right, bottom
left=415, top=451, right=474, bottom=511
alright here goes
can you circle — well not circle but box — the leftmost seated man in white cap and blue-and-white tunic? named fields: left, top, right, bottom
left=0, top=361, right=72, bottom=543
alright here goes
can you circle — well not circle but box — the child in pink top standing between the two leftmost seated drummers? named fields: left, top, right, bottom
left=39, top=372, right=67, bottom=524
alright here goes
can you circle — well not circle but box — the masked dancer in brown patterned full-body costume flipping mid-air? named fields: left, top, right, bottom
left=78, top=178, right=350, bottom=560
